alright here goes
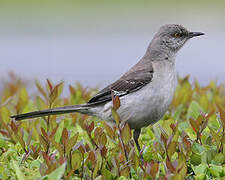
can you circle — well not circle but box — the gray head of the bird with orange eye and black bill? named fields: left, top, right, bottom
left=152, top=24, right=204, bottom=53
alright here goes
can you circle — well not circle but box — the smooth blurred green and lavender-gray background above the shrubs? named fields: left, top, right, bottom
left=0, top=0, right=225, bottom=93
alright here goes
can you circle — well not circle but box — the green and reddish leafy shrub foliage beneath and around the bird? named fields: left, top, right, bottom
left=0, top=75, right=225, bottom=180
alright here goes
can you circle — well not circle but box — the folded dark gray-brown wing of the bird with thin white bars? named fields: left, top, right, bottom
left=88, top=67, right=153, bottom=104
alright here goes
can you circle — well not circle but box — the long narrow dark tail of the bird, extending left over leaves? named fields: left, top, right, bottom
left=11, top=104, right=89, bottom=121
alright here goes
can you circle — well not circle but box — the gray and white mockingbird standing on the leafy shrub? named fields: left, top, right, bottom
left=12, top=24, right=204, bottom=155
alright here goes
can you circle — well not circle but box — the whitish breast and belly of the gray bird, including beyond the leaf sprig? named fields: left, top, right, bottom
left=90, top=62, right=176, bottom=129
